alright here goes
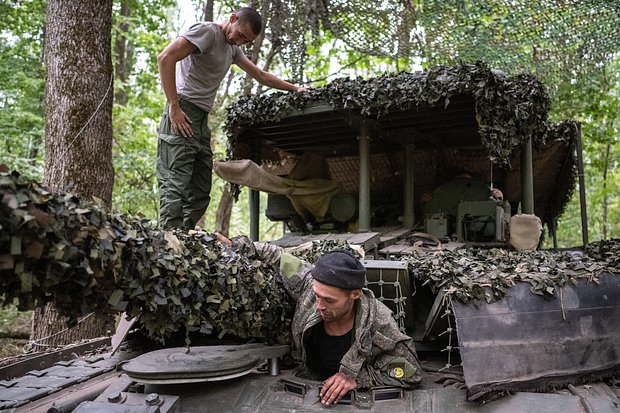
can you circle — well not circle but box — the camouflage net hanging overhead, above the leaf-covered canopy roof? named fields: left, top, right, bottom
left=264, top=0, right=620, bottom=81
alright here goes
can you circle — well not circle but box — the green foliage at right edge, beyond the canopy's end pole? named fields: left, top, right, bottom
left=553, top=57, right=620, bottom=246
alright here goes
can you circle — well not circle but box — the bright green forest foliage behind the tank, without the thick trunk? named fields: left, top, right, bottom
left=0, top=0, right=620, bottom=246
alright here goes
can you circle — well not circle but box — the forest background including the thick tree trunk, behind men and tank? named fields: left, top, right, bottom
left=0, top=0, right=620, bottom=354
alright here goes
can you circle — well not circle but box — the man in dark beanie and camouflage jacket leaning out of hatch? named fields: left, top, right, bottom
left=218, top=234, right=422, bottom=404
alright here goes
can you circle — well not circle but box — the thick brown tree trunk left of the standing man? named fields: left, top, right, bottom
left=31, top=0, right=114, bottom=346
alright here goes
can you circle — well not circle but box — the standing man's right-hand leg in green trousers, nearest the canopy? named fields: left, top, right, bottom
left=183, top=116, right=213, bottom=229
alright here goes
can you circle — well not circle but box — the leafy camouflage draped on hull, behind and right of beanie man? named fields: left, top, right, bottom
left=268, top=239, right=620, bottom=305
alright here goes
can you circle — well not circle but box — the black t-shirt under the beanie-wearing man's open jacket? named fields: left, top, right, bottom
left=304, top=321, right=353, bottom=380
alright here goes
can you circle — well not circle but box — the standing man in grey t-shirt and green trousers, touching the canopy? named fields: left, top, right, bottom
left=157, top=7, right=305, bottom=229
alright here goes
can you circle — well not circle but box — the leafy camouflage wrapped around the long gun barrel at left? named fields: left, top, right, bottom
left=0, top=173, right=292, bottom=342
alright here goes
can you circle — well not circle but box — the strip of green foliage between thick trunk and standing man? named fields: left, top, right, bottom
left=113, top=0, right=176, bottom=219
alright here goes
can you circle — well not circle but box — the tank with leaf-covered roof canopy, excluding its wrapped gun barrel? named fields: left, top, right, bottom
left=0, top=64, right=620, bottom=413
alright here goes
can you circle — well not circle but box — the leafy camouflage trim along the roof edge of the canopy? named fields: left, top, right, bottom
left=224, top=62, right=577, bottom=165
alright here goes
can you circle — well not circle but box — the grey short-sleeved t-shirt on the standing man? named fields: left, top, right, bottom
left=176, top=22, right=243, bottom=112
